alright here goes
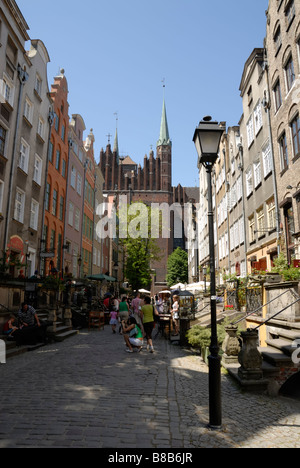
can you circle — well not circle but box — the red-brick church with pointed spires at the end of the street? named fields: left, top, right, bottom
left=99, top=101, right=198, bottom=294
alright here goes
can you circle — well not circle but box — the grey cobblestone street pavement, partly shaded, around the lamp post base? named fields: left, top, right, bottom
left=0, top=326, right=300, bottom=449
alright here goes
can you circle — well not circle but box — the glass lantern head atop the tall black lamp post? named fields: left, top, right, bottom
left=193, top=117, right=224, bottom=165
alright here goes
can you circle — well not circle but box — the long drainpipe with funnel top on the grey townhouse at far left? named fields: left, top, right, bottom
left=3, top=65, right=29, bottom=252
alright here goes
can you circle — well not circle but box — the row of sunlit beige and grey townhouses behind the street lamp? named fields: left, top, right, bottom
left=198, top=0, right=300, bottom=283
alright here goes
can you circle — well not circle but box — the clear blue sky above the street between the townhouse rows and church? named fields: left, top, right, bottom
left=17, top=0, right=268, bottom=186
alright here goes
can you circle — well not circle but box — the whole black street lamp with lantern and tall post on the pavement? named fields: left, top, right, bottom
left=193, top=117, right=225, bottom=429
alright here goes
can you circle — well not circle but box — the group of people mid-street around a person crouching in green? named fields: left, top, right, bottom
left=104, top=293, right=179, bottom=353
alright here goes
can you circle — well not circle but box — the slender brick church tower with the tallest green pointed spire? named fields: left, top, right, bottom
left=156, top=99, right=172, bottom=192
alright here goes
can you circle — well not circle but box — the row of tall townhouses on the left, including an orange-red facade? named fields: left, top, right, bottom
left=0, top=0, right=109, bottom=277
